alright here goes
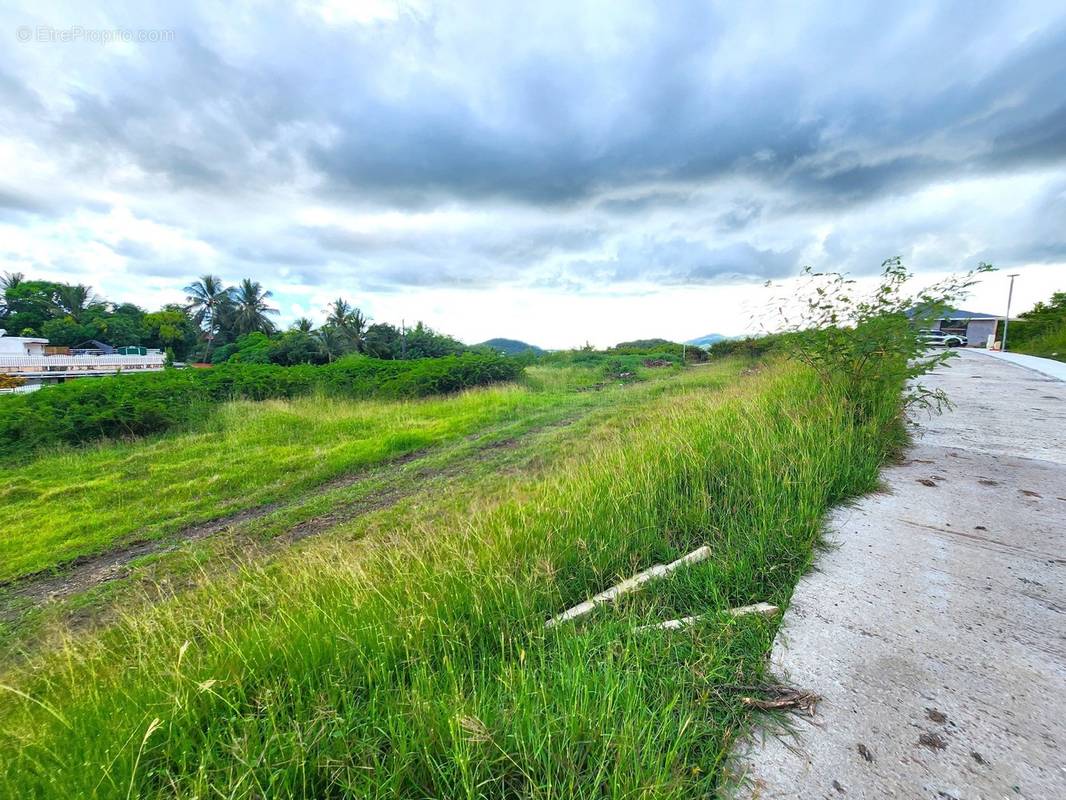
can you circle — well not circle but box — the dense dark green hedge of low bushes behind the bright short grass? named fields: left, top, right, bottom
left=0, top=354, right=522, bottom=459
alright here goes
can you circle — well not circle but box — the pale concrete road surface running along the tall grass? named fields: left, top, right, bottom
left=732, top=352, right=1066, bottom=800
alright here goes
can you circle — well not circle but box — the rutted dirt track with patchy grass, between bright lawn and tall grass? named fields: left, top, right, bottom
left=0, top=364, right=740, bottom=657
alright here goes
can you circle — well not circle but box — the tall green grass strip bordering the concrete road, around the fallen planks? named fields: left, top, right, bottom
left=0, top=365, right=898, bottom=798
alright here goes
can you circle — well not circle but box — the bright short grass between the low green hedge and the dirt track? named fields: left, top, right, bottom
left=0, top=369, right=601, bottom=581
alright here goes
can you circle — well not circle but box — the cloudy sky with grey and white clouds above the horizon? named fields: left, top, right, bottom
left=0, top=0, right=1066, bottom=348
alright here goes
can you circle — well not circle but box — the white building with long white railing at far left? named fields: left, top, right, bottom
left=0, top=330, right=165, bottom=385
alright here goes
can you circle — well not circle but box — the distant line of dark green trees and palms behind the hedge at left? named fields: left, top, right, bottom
left=0, top=272, right=469, bottom=366
